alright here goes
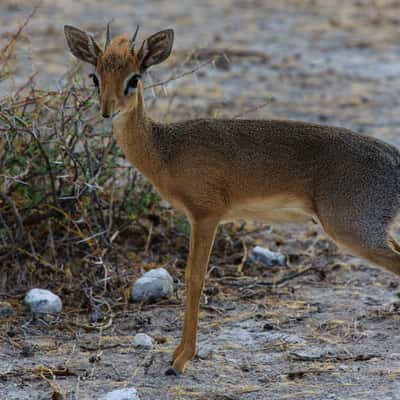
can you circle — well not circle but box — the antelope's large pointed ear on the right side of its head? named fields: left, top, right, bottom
left=137, top=29, right=174, bottom=72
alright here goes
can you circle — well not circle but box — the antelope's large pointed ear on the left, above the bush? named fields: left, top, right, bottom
left=64, top=25, right=102, bottom=66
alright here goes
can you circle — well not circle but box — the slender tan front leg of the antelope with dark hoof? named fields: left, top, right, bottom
left=166, top=219, right=218, bottom=375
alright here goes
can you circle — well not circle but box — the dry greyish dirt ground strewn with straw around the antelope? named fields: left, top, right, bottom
left=0, top=0, right=400, bottom=400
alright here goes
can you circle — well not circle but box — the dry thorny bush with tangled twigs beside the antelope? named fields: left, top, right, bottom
left=0, top=17, right=171, bottom=304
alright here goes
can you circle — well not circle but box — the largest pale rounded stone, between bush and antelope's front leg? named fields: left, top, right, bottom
left=132, top=268, right=174, bottom=301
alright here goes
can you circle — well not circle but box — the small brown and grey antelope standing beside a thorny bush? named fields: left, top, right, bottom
left=64, top=26, right=400, bottom=375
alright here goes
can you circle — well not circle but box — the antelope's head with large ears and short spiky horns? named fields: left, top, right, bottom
left=64, top=25, right=174, bottom=118
